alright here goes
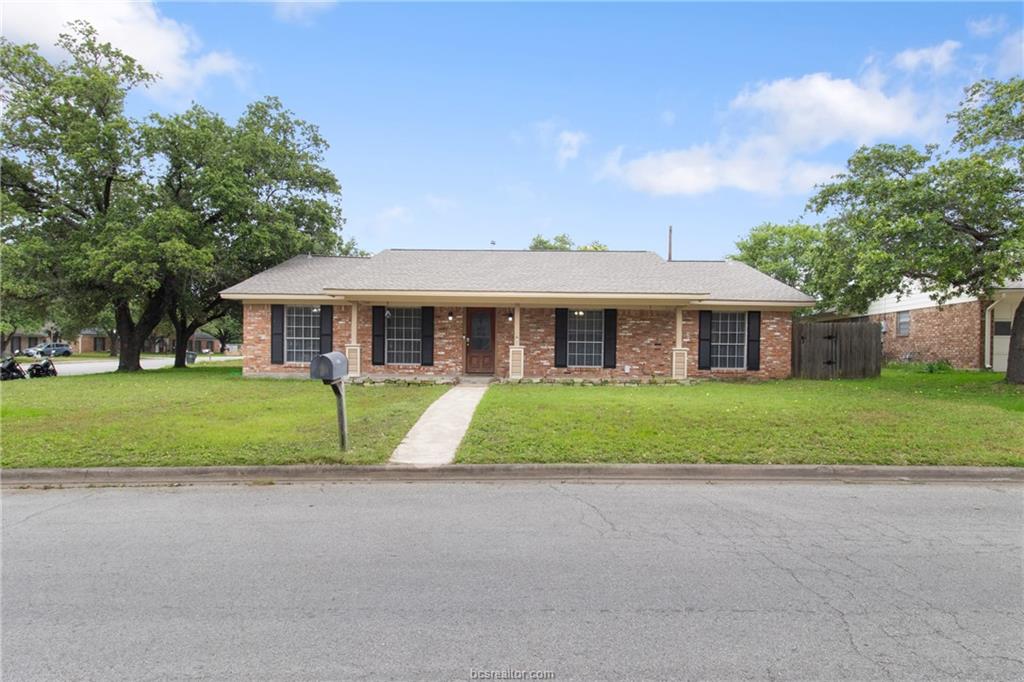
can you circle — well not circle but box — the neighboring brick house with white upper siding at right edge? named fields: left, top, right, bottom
left=827, top=281, right=1024, bottom=372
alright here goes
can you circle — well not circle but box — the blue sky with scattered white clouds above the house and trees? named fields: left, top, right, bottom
left=4, top=2, right=1024, bottom=258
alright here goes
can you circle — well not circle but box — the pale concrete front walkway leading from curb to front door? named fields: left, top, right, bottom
left=391, top=385, right=487, bottom=467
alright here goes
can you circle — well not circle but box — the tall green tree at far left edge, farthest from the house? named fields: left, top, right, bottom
left=0, top=23, right=172, bottom=370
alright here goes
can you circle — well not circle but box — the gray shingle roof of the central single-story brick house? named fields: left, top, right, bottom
left=222, top=249, right=813, bottom=303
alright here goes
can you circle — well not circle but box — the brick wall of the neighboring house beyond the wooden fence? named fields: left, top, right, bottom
left=868, top=301, right=987, bottom=370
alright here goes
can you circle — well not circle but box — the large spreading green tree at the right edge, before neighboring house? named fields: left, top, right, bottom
left=809, top=78, right=1024, bottom=383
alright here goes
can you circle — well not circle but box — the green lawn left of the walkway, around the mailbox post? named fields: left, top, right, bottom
left=0, top=360, right=446, bottom=467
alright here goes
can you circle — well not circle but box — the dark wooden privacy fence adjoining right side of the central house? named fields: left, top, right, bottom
left=793, top=322, right=882, bottom=379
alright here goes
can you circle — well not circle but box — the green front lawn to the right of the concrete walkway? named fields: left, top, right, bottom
left=457, top=368, right=1024, bottom=466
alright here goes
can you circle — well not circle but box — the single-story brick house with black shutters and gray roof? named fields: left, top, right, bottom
left=221, top=250, right=814, bottom=381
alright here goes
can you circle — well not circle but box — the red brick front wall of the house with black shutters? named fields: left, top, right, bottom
left=243, top=303, right=792, bottom=381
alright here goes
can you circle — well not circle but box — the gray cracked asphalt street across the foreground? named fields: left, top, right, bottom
left=2, top=483, right=1024, bottom=681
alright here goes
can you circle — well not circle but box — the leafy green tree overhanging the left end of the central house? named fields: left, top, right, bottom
left=143, top=98, right=354, bottom=367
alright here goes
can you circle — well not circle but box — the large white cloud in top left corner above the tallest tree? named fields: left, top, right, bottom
left=3, top=0, right=246, bottom=97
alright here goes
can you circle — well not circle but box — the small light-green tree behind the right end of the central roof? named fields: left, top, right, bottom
left=731, top=222, right=821, bottom=296
